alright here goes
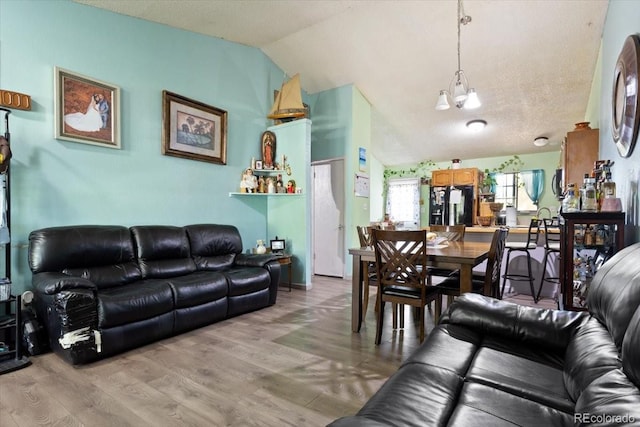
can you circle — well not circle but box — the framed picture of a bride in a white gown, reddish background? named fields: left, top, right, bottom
left=54, top=67, right=120, bottom=149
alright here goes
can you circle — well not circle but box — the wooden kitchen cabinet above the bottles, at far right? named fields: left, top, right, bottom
left=562, top=123, right=600, bottom=190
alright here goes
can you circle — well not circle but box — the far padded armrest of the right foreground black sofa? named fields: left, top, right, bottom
left=441, top=293, right=589, bottom=350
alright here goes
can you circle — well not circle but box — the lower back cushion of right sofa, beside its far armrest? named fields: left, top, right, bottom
left=563, top=317, right=621, bottom=401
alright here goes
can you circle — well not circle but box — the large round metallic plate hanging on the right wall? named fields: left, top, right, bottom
left=611, top=35, right=640, bottom=157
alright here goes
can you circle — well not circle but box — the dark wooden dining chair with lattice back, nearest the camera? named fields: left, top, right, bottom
left=372, top=229, right=438, bottom=345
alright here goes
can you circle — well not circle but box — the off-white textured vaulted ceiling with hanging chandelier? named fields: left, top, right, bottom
left=76, top=0, right=608, bottom=165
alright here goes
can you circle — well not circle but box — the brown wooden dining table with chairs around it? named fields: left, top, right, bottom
left=349, top=241, right=491, bottom=332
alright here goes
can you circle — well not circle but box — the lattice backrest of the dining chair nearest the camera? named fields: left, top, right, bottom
left=372, top=229, right=427, bottom=288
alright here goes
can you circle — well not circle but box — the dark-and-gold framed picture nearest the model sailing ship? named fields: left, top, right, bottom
left=162, top=90, right=227, bottom=165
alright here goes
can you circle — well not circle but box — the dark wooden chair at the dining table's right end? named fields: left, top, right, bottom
left=433, top=227, right=509, bottom=324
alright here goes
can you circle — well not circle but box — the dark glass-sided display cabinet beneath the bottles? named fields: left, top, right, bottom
left=559, top=212, right=625, bottom=310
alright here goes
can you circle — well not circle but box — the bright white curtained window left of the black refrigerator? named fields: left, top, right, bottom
left=386, top=178, right=420, bottom=226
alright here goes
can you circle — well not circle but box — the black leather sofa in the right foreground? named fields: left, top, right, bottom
left=330, top=243, right=640, bottom=427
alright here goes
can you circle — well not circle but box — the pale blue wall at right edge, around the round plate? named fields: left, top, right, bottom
left=599, top=0, right=640, bottom=244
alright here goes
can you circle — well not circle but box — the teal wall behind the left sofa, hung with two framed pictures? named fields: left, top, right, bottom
left=0, top=0, right=283, bottom=292
